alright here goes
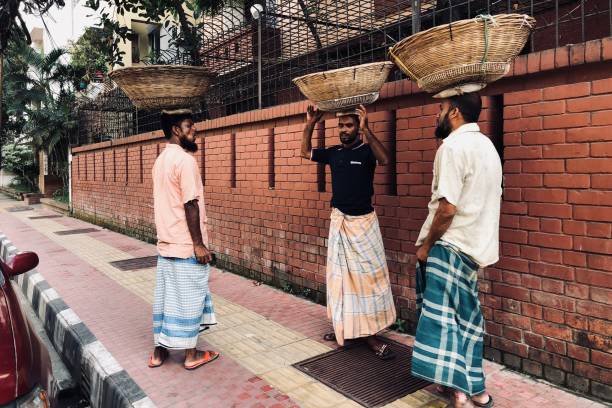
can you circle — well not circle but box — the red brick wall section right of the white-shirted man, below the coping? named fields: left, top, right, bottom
left=483, top=78, right=612, bottom=391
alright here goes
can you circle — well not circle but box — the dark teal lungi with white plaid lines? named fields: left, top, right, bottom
left=412, top=241, right=485, bottom=396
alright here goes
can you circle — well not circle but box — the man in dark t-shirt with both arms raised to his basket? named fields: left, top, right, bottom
left=301, top=105, right=396, bottom=359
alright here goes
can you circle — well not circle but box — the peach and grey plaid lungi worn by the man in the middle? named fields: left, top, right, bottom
left=326, top=208, right=396, bottom=345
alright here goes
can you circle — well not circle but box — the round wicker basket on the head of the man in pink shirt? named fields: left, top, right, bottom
left=109, top=65, right=216, bottom=109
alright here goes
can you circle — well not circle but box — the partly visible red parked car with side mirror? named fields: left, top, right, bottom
left=0, top=252, right=55, bottom=408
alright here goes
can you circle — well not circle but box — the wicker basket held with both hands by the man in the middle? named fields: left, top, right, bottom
left=293, top=61, right=393, bottom=111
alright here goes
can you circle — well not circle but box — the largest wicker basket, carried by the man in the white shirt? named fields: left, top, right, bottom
left=389, top=14, right=535, bottom=97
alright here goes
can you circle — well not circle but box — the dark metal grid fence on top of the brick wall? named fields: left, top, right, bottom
left=78, top=0, right=612, bottom=144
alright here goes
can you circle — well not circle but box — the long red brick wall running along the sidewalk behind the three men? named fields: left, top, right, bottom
left=72, top=39, right=612, bottom=399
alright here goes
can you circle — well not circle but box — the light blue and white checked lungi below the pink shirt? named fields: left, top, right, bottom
left=153, top=256, right=217, bottom=349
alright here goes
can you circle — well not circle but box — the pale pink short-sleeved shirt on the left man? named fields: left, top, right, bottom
left=153, top=144, right=208, bottom=258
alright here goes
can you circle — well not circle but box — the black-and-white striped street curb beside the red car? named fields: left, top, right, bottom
left=0, top=232, right=155, bottom=408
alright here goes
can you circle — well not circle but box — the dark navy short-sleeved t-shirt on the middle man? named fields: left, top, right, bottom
left=311, top=142, right=376, bottom=215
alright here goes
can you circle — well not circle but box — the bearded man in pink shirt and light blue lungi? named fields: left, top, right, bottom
left=149, top=110, right=219, bottom=370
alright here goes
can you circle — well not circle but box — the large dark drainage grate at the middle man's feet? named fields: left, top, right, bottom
left=294, top=339, right=431, bottom=408
